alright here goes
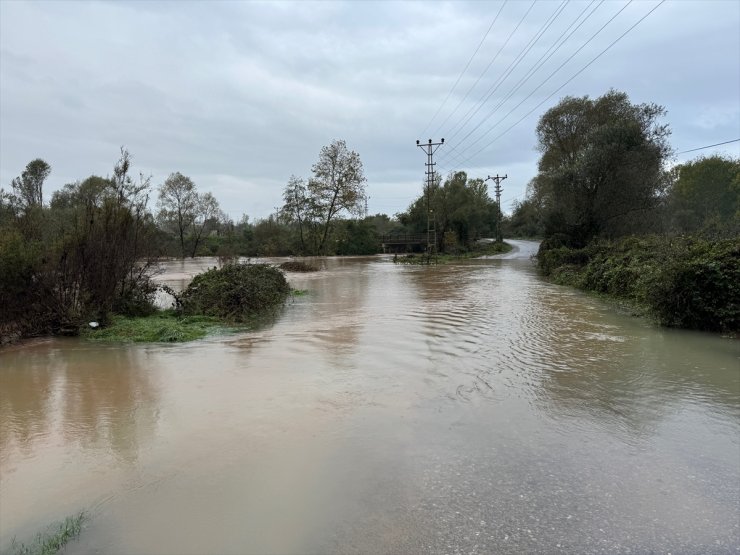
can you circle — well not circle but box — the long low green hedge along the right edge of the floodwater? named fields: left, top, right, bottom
left=537, top=236, right=740, bottom=333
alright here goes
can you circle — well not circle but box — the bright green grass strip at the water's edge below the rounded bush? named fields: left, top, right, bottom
left=82, top=310, right=228, bottom=343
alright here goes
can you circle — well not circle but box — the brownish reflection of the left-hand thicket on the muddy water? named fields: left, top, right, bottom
left=0, top=340, right=157, bottom=463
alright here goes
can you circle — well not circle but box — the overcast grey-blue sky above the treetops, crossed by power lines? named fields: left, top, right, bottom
left=0, top=0, right=740, bottom=219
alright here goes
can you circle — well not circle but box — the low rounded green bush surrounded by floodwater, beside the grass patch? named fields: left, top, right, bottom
left=180, top=264, right=290, bottom=322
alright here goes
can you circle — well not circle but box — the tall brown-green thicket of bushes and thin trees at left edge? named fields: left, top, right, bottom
left=0, top=150, right=156, bottom=342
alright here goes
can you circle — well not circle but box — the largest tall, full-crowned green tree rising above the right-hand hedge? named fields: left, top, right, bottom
left=533, top=90, right=670, bottom=246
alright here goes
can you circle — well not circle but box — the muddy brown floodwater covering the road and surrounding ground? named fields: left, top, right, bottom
left=0, top=242, right=740, bottom=554
